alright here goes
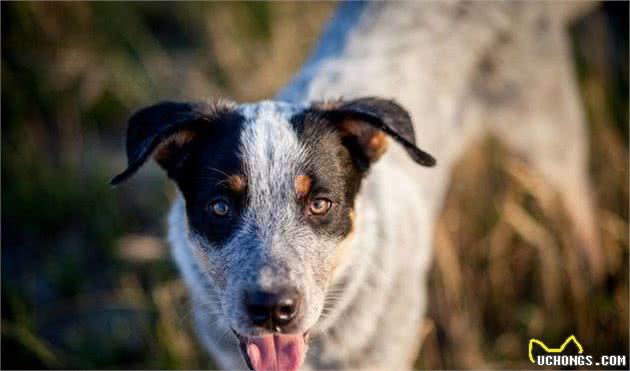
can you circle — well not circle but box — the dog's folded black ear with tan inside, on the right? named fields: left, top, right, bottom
left=315, top=97, right=436, bottom=169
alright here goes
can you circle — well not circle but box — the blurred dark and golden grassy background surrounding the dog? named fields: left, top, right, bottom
left=1, top=2, right=629, bottom=369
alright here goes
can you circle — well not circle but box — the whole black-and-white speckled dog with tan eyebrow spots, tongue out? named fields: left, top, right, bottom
left=112, top=2, right=599, bottom=371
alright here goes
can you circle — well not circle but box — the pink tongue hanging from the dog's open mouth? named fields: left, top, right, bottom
left=247, top=334, right=305, bottom=371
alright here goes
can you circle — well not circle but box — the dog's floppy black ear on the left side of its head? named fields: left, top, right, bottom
left=111, top=101, right=234, bottom=185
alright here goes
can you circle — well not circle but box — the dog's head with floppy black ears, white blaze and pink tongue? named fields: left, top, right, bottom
left=113, top=98, right=434, bottom=369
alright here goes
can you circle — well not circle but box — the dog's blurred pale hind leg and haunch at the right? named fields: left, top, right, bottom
left=470, top=6, right=604, bottom=282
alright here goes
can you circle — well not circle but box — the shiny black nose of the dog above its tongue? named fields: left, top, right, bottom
left=244, top=290, right=300, bottom=331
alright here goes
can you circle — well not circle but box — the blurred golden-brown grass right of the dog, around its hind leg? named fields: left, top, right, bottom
left=417, top=3, right=629, bottom=369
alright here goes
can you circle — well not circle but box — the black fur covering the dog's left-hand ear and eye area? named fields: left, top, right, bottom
left=112, top=102, right=245, bottom=247
